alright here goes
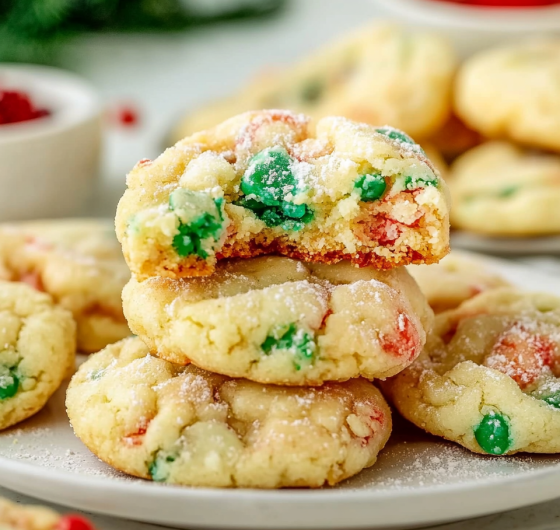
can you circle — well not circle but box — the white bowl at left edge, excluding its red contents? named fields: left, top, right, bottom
left=0, top=64, right=101, bottom=221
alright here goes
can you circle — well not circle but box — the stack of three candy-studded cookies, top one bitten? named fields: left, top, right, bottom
left=67, top=111, right=449, bottom=488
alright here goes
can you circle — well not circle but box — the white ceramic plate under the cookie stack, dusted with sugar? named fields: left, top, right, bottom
left=0, top=254, right=560, bottom=529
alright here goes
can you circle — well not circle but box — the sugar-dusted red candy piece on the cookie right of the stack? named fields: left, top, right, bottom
left=484, top=324, right=557, bottom=390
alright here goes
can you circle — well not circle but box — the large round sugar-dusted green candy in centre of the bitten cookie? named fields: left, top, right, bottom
left=241, top=146, right=296, bottom=206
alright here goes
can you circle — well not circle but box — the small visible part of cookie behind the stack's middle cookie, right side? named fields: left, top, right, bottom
left=408, top=251, right=509, bottom=313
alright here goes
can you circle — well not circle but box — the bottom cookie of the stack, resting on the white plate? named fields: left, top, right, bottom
left=66, top=338, right=391, bottom=488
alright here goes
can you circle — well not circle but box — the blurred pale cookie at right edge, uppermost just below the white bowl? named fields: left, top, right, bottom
left=455, top=38, right=560, bottom=151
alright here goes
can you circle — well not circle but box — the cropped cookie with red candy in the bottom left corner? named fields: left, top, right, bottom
left=0, top=497, right=94, bottom=530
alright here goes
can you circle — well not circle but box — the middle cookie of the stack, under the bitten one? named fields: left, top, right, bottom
left=123, top=257, right=432, bottom=385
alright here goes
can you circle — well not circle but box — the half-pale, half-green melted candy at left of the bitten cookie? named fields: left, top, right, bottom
left=169, top=189, right=224, bottom=259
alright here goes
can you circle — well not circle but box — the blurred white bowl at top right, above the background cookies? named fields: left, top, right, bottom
left=373, top=0, right=560, bottom=57
